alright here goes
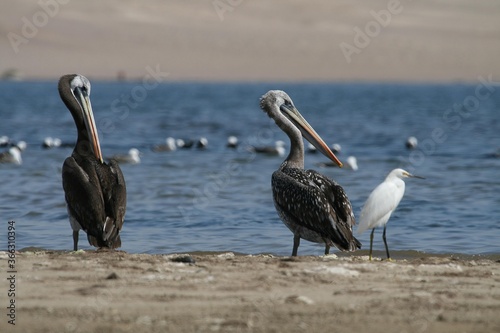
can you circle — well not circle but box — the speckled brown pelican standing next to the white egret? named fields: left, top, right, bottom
left=260, top=90, right=361, bottom=256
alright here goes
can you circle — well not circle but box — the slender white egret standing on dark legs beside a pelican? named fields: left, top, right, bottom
left=357, top=169, right=423, bottom=260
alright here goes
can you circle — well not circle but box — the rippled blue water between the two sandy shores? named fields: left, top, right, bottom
left=0, top=81, right=500, bottom=255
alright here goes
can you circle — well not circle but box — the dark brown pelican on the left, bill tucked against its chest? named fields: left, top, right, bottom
left=58, top=74, right=127, bottom=251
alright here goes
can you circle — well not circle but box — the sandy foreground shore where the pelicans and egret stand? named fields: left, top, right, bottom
left=0, top=249, right=500, bottom=333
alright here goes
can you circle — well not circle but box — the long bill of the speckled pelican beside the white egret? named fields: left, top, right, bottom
left=280, top=104, right=343, bottom=168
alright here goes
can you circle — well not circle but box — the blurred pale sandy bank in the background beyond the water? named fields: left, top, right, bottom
left=0, top=0, right=500, bottom=82
